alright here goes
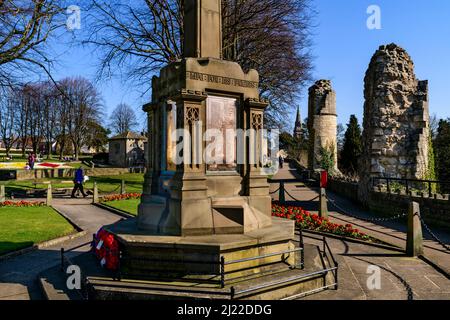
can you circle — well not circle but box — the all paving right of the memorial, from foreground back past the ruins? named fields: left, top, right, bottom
left=270, top=165, right=450, bottom=299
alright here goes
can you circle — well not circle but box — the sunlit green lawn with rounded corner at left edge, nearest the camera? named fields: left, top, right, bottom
left=0, top=207, right=75, bottom=255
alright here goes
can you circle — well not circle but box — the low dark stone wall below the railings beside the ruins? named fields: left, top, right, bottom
left=328, top=179, right=450, bottom=228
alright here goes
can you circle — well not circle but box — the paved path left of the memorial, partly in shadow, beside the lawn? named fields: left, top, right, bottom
left=0, top=199, right=121, bottom=300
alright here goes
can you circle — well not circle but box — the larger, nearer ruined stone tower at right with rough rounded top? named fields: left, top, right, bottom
left=359, top=44, right=429, bottom=204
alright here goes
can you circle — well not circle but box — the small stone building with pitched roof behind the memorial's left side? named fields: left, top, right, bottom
left=109, top=132, right=147, bottom=168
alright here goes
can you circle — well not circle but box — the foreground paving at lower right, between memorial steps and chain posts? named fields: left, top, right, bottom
left=304, top=238, right=450, bottom=300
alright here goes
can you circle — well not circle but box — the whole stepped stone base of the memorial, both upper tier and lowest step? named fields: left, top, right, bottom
left=86, top=218, right=333, bottom=300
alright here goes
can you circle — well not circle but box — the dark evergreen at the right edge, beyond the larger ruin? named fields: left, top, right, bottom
left=434, top=119, right=450, bottom=193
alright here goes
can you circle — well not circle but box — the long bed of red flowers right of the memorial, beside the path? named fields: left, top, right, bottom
left=272, top=203, right=374, bottom=241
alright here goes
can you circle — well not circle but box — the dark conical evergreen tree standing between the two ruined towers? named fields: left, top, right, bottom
left=340, top=115, right=362, bottom=174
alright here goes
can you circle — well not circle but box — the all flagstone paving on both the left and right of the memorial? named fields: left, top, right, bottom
left=0, top=166, right=450, bottom=300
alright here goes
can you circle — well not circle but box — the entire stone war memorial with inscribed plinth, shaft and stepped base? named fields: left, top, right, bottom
left=90, top=0, right=331, bottom=299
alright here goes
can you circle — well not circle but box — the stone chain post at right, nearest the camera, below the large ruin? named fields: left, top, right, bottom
left=406, top=202, right=423, bottom=257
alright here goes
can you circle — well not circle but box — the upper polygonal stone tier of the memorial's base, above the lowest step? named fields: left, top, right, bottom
left=105, top=218, right=300, bottom=283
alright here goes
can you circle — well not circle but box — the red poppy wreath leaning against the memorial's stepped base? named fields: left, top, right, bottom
left=92, top=228, right=119, bottom=271
